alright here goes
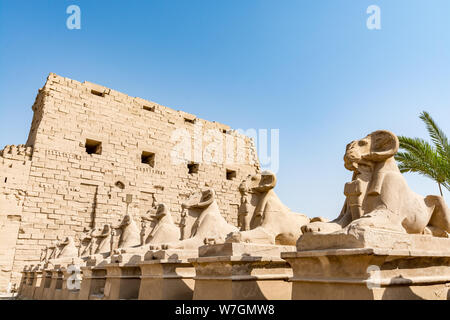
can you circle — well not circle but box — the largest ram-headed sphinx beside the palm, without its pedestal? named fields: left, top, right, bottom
left=302, top=130, right=450, bottom=237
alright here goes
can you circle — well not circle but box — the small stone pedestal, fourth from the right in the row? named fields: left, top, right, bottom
left=104, top=263, right=141, bottom=300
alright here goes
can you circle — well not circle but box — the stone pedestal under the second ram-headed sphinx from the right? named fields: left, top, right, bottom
left=189, top=243, right=295, bottom=300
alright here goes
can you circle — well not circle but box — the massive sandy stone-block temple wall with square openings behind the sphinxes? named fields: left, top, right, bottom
left=0, top=74, right=259, bottom=292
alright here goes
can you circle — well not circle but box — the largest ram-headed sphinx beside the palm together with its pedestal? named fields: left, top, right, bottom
left=281, top=130, right=450, bottom=300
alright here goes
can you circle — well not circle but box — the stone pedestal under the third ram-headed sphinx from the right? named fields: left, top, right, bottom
left=139, top=249, right=198, bottom=300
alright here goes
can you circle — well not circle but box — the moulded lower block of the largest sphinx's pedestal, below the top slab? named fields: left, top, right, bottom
left=281, top=242, right=450, bottom=300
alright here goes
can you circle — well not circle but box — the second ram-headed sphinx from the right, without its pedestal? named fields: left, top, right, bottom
left=227, top=171, right=310, bottom=245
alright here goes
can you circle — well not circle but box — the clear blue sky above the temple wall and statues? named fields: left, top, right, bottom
left=0, top=0, right=450, bottom=218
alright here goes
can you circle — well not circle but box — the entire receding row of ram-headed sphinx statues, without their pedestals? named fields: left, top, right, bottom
left=39, top=130, right=450, bottom=260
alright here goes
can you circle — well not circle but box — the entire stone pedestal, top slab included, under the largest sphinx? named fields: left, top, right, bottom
left=281, top=230, right=450, bottom=300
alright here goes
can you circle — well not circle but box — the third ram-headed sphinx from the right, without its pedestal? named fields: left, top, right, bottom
left=154, top=188, right=238, bottom=249
